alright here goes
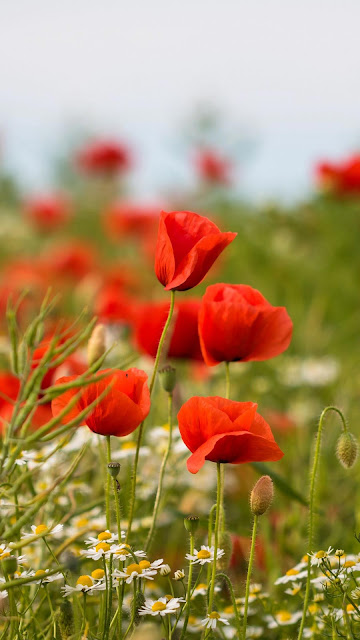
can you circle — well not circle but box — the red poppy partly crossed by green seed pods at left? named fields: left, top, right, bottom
left=52, top=368, right=150, bottom=436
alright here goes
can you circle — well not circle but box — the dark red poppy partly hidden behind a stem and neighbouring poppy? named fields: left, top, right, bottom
left=134, top=299, right=203, bottom=361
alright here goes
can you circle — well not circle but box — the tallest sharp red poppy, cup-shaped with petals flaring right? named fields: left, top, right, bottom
left=155, top=211, right=237, bottom=291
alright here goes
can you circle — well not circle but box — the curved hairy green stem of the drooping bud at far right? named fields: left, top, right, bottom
left=298, top=407, right=347, bottom=640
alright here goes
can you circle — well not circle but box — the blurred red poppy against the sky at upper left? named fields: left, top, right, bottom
left=76, top=140, right=131, bottom=174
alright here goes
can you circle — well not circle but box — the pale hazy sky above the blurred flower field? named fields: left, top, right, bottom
left=0, top=0, right=360, bottom=200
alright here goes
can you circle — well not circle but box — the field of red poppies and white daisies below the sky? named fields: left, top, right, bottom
left=0, top=140, right=360, bottom=640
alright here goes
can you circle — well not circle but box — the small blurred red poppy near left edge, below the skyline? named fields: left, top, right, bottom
left=25, top=195, right=70, bottom=231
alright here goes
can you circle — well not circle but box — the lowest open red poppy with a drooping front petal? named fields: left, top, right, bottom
left=178, top=396, right=284, bottom=473
